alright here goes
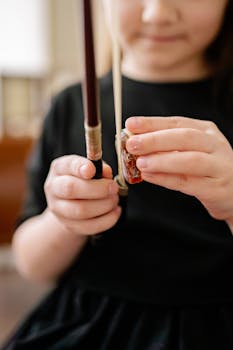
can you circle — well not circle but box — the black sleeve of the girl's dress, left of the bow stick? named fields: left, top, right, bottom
left=17, top=84, right=89, bottom=226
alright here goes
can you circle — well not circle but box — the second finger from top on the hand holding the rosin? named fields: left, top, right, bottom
left=127, top=128, right=216, bottom=155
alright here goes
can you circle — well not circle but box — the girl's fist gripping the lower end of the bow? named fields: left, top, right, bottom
left=45, top=155, right=121, bottom=235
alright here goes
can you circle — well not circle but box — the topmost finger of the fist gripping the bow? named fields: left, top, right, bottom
left=51, top=155, right=96, bottom=179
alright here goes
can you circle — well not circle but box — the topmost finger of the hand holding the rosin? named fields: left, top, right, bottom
left=125, top=116, right=217, bottom=134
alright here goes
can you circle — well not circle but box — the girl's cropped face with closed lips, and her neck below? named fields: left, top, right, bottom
left=103, top=0, right=228, bottom=80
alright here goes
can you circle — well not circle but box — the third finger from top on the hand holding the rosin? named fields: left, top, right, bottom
left=136, top=152, right=217, bottom=177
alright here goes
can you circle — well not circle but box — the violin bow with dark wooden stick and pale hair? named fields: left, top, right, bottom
left=82, top=0, right=128, bottom=227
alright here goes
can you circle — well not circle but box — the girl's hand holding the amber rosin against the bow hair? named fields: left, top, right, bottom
left=126, top=117, right=233, bottom=223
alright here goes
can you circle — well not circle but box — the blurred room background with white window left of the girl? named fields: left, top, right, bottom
left=0, top=0, right=111, bottom=345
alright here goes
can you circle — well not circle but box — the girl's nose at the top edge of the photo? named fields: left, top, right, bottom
left=141, top=0, right=179, bottom=24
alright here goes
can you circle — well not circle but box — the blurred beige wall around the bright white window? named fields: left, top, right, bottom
left=0, top=0, right=111, bottom=136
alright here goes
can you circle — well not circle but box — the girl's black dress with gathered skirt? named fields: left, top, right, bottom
left=3, top=73, right=233, bottom=350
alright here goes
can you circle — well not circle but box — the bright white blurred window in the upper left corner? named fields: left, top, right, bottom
left=0, top=0, right=50, bottom=76
